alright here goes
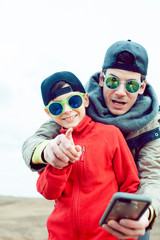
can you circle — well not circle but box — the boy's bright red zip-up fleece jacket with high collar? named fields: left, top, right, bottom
left=37, top=116, right=140, bottom=240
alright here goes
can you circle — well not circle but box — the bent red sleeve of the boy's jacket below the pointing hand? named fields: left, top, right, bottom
left=37, top=164, right=72, bottom=200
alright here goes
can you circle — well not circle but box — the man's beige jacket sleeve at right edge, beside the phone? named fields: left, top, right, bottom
left=137, top=139, right=160, bottom=216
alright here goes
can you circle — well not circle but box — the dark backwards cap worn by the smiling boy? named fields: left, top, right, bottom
left=41, top=71, right=85, bottom=106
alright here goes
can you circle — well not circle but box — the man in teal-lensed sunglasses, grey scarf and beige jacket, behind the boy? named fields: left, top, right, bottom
left=23, top=40, right=160, bottom=239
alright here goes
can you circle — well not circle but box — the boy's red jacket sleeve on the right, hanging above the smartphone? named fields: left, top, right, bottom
left=113, top=129, right=140, bottom=193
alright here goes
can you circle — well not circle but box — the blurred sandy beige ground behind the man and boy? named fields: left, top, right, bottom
left=0, top=196, right=160, bottom=240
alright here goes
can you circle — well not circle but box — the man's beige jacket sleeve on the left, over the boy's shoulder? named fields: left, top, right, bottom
left=22, top=119, right=61, bottom=171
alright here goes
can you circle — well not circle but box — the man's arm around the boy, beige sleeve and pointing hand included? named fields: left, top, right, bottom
left=22, top=119, right=81, bottom=171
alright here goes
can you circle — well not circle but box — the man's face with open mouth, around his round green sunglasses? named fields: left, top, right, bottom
left=99, top=68, right=146, bottom=115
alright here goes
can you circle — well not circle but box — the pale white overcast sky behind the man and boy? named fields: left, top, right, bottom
left=0, top=0, right=160, bottom=195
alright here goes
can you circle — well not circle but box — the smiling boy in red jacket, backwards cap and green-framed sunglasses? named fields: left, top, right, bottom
left=37, top=72, right=140, bottom=240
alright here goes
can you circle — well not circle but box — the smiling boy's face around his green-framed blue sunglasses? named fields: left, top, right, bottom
left=45, top=92, right=89, bottom=129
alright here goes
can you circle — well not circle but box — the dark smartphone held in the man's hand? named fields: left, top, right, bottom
left=99, top=192, right=152, bottom=226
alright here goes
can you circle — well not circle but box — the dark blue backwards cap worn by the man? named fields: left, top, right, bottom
left=102, top=40, right=148, bottom=76
